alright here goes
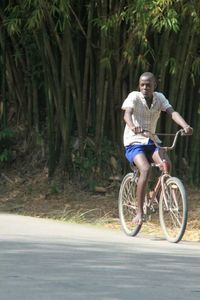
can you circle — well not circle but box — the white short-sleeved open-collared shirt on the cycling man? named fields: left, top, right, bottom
left=122, top=91, right=172, bottom=146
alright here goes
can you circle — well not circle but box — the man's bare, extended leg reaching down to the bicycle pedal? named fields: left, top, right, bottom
left=133, top=153, right=150, bottom=224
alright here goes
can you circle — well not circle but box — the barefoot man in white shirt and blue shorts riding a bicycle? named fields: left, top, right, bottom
left=122, top=72, right=193, bottom=224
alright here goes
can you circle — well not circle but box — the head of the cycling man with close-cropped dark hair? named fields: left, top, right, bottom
left=139, top=72, right=156, bottom=99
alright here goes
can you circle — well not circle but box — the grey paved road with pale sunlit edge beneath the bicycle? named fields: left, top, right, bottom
left=0, top=214, right=200, bottom=300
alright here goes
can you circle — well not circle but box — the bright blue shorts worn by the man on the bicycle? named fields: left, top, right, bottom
left=125, top=139, right=159, bottom=164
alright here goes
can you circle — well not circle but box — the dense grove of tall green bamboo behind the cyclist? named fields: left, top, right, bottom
left=0, top=0, right=200, bottom=185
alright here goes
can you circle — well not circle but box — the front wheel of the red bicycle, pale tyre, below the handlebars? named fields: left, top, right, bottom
left=159, top=177, right=188, bottom=243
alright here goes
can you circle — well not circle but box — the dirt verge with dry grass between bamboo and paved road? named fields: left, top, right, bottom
left=0, top=168, right=200, bottom=241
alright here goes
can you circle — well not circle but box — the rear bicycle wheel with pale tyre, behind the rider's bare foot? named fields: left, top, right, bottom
left=118, top=173, right=142, bottom=236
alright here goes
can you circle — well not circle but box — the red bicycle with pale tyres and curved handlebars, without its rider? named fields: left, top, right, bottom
left=118, top=129, right=188, bottom=243
